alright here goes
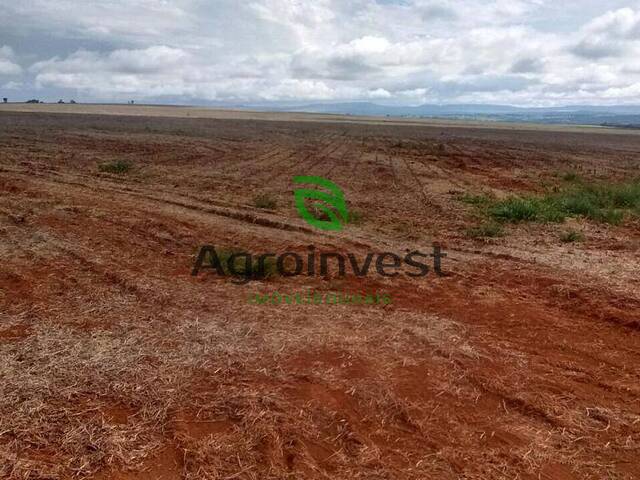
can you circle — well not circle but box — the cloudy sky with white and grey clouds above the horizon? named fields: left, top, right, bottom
left=0, top=0, right=640, bottom=106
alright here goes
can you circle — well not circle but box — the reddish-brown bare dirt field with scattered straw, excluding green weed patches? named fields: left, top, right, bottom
left=0, top=111, right=640, bottom=480
